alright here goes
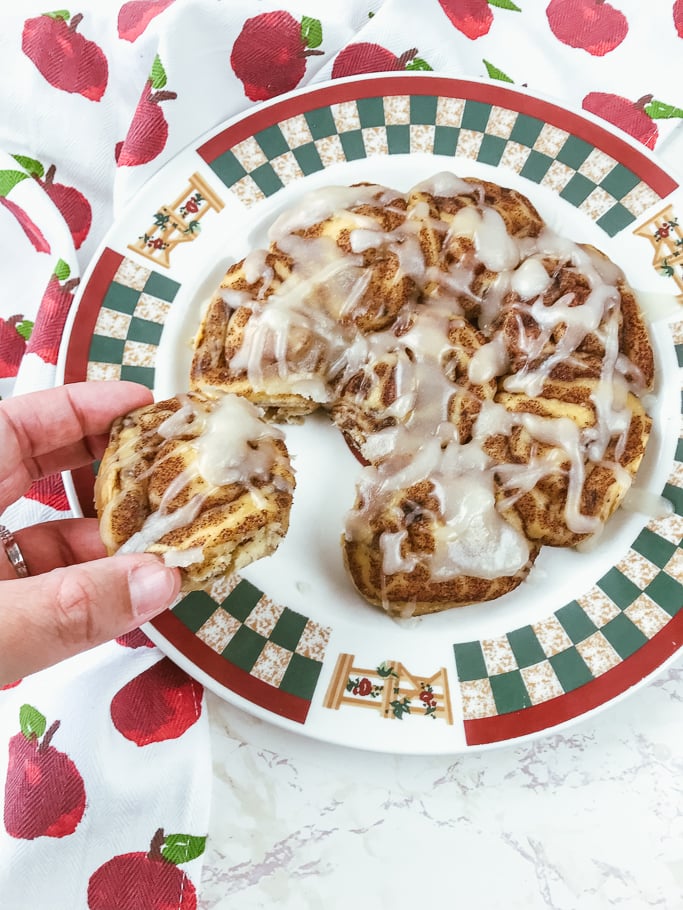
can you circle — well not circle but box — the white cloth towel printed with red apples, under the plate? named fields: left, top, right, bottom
left=0, top=0, right=683, bottom=910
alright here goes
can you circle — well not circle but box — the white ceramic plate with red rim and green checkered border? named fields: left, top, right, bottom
left=57, top=74, right=683, bottom=753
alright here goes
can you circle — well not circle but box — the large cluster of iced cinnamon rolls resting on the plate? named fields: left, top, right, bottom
left=190, top=173, right=654, bottom=615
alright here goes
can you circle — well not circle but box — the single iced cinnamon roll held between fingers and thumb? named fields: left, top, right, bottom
left=95, top=392, right=294, bottom=591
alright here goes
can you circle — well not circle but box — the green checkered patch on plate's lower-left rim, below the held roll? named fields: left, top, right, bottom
left=173, top=576, right=329, bottom=701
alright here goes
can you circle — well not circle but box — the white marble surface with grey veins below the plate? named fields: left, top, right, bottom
left=199, top=659, right=683, bottom=910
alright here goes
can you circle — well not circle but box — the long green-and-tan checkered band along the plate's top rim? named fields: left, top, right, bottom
left=203, top=96, right=660, bottom=236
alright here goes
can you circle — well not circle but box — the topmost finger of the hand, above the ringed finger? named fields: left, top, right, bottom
left=0, top=382, right=152, bottom=510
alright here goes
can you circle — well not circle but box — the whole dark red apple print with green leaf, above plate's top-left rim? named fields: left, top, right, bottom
left=230, top=10, right=323, bottom=101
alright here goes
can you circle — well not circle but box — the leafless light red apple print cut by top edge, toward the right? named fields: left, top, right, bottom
left=546, top=0, right=628, bottom=57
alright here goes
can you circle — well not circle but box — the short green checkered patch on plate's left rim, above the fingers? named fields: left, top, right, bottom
left=87, top=258, right=180, bottom=389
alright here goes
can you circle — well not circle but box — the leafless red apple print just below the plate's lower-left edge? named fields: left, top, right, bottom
left=111, top=657, right=203, bottom=746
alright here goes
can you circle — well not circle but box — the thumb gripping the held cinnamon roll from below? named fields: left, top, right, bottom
left=0, top=553, right=180, bottom=685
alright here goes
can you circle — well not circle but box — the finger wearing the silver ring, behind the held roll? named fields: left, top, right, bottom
left=0, top=518, right=107, bottom=581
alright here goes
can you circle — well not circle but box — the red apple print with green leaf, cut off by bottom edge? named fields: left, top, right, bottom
left=88, top=828, right=206, bottom=910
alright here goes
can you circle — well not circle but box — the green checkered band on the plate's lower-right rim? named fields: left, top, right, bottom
left=454, top=478, right=683, bottom=720
